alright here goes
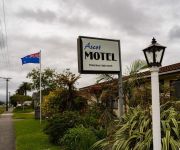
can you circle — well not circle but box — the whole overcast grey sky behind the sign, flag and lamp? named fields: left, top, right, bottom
left=0, top=0, right=180, bottom=99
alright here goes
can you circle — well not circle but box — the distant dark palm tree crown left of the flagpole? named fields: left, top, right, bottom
left=16, top=82, right=31, bottom=96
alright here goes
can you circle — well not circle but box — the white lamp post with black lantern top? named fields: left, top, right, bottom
left=143, top=38, right=166, bottom=150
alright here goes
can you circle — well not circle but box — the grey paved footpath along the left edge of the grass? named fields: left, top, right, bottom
left=0, top=110, right=15, bottom=150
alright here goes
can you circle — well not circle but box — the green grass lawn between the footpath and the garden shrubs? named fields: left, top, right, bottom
left=13, top=113, right=60, bottom=150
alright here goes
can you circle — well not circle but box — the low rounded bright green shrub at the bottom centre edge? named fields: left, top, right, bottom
left=61, top=127, right=96, bottom=150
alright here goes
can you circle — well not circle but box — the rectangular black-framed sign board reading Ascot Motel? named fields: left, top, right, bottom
left=78, top=36, right=120, bottom=74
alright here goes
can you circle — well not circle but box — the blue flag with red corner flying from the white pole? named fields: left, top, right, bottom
left=21, top=52, right=40, bottom=65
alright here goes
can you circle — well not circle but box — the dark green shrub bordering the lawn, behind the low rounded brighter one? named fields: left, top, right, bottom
left=44, top=111, right=84, bottom=144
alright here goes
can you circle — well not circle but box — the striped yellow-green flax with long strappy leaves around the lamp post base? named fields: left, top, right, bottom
left=92, top=103, right=180, bottom=150
